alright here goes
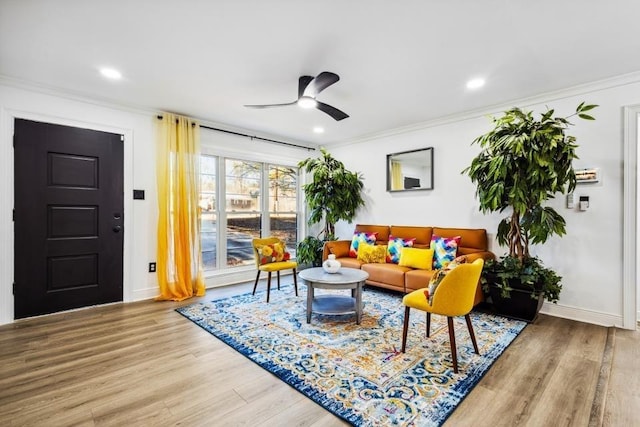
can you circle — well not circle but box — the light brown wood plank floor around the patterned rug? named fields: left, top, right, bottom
left=0, top=283, right=640, bottom=427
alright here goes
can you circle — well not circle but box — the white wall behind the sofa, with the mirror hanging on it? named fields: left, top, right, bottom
left=330, top=77, right=640, bottom=325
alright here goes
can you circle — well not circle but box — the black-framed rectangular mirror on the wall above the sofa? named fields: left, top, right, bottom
left=387, top=147, right=433, bottom=191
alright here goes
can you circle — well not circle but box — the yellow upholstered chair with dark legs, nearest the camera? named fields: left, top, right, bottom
left=402, top=258, right=484, bottom=373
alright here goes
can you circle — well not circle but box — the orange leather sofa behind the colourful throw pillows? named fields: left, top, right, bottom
left=323, top=224, right=495, bottom=305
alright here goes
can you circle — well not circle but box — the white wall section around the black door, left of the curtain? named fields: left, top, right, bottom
left=0, top=85, right=157, bottom=324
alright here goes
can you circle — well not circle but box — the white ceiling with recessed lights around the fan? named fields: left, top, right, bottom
left=0, top=0, right=640, bottom=145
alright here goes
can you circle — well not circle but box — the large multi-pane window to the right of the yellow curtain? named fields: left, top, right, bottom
left=200, top=155, right=298, bottom=271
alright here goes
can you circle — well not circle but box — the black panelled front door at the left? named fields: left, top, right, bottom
left=14, top=119, right=124, bottom=319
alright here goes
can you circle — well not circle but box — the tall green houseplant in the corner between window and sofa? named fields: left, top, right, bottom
left=296, top=148, right=364, bottom=266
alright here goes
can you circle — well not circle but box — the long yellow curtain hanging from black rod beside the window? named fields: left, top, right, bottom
left=156, top=113, right=205, bottom=301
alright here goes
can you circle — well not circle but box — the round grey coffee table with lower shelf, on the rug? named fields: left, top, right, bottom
left=298, top=267, right=369, bottom=325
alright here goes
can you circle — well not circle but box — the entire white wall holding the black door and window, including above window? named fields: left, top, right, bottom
left=0, top=82, right=315, bottom=324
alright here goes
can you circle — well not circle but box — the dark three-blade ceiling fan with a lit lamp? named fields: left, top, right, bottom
left=245, top=71, right=349, bottom=120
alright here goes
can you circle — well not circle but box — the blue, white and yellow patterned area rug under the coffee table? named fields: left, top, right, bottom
left=177, top=286, right=526, bottom=426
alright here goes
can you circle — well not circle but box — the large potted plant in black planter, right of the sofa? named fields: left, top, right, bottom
left=462, top=102, right=596, bottom=321
